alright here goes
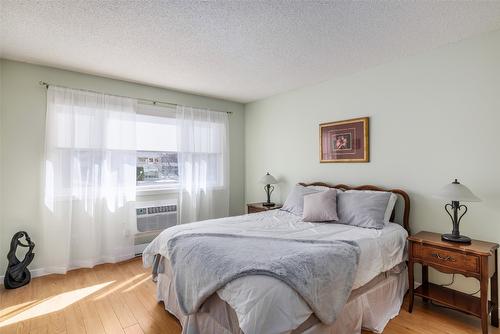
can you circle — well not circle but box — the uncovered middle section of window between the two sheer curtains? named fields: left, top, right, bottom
left=136, top=105, right=179, bottom=189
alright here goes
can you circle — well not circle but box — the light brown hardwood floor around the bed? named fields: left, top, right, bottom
left=0, top=259, right=500, bottom=334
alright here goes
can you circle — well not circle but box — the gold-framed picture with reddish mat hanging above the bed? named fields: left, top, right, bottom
left=319, top=117, right=370, bottom=162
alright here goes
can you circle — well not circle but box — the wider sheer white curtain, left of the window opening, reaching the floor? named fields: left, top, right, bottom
left=39, top=86, right=136, bottom=273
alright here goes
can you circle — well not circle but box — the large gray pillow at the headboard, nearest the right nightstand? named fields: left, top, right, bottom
left=337, top=191, right=391, bottom=230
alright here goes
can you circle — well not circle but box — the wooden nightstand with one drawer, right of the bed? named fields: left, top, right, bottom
left=408, top=232, right=498, bottom=334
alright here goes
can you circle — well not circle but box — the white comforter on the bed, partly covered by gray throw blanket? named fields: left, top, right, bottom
left=143, top=210, right=407, bottom=334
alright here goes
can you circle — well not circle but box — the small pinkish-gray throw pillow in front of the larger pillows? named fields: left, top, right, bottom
left=302, top=189, right=339, bottom=222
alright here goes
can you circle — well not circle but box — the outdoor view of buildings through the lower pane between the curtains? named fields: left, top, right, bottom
left=136, top=151, right=179, bottom=186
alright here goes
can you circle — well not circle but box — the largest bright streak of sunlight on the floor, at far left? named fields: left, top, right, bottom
left=0, top=281, right=114, bottom=327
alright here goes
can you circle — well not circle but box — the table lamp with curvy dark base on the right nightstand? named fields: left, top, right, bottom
left=434, top=179, right=481, bottom=243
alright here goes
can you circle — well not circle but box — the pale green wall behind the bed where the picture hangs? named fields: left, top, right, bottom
left=245, top=31, right=500, bottom=291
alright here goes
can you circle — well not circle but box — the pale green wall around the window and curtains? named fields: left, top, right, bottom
left=0, top=60, right=244, bottom=275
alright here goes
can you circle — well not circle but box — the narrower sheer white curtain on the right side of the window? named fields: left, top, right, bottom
left=176, top=106, right=229, bottom=223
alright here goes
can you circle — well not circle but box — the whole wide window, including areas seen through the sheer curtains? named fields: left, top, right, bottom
left=46, top=90, right=229, bottom=202
